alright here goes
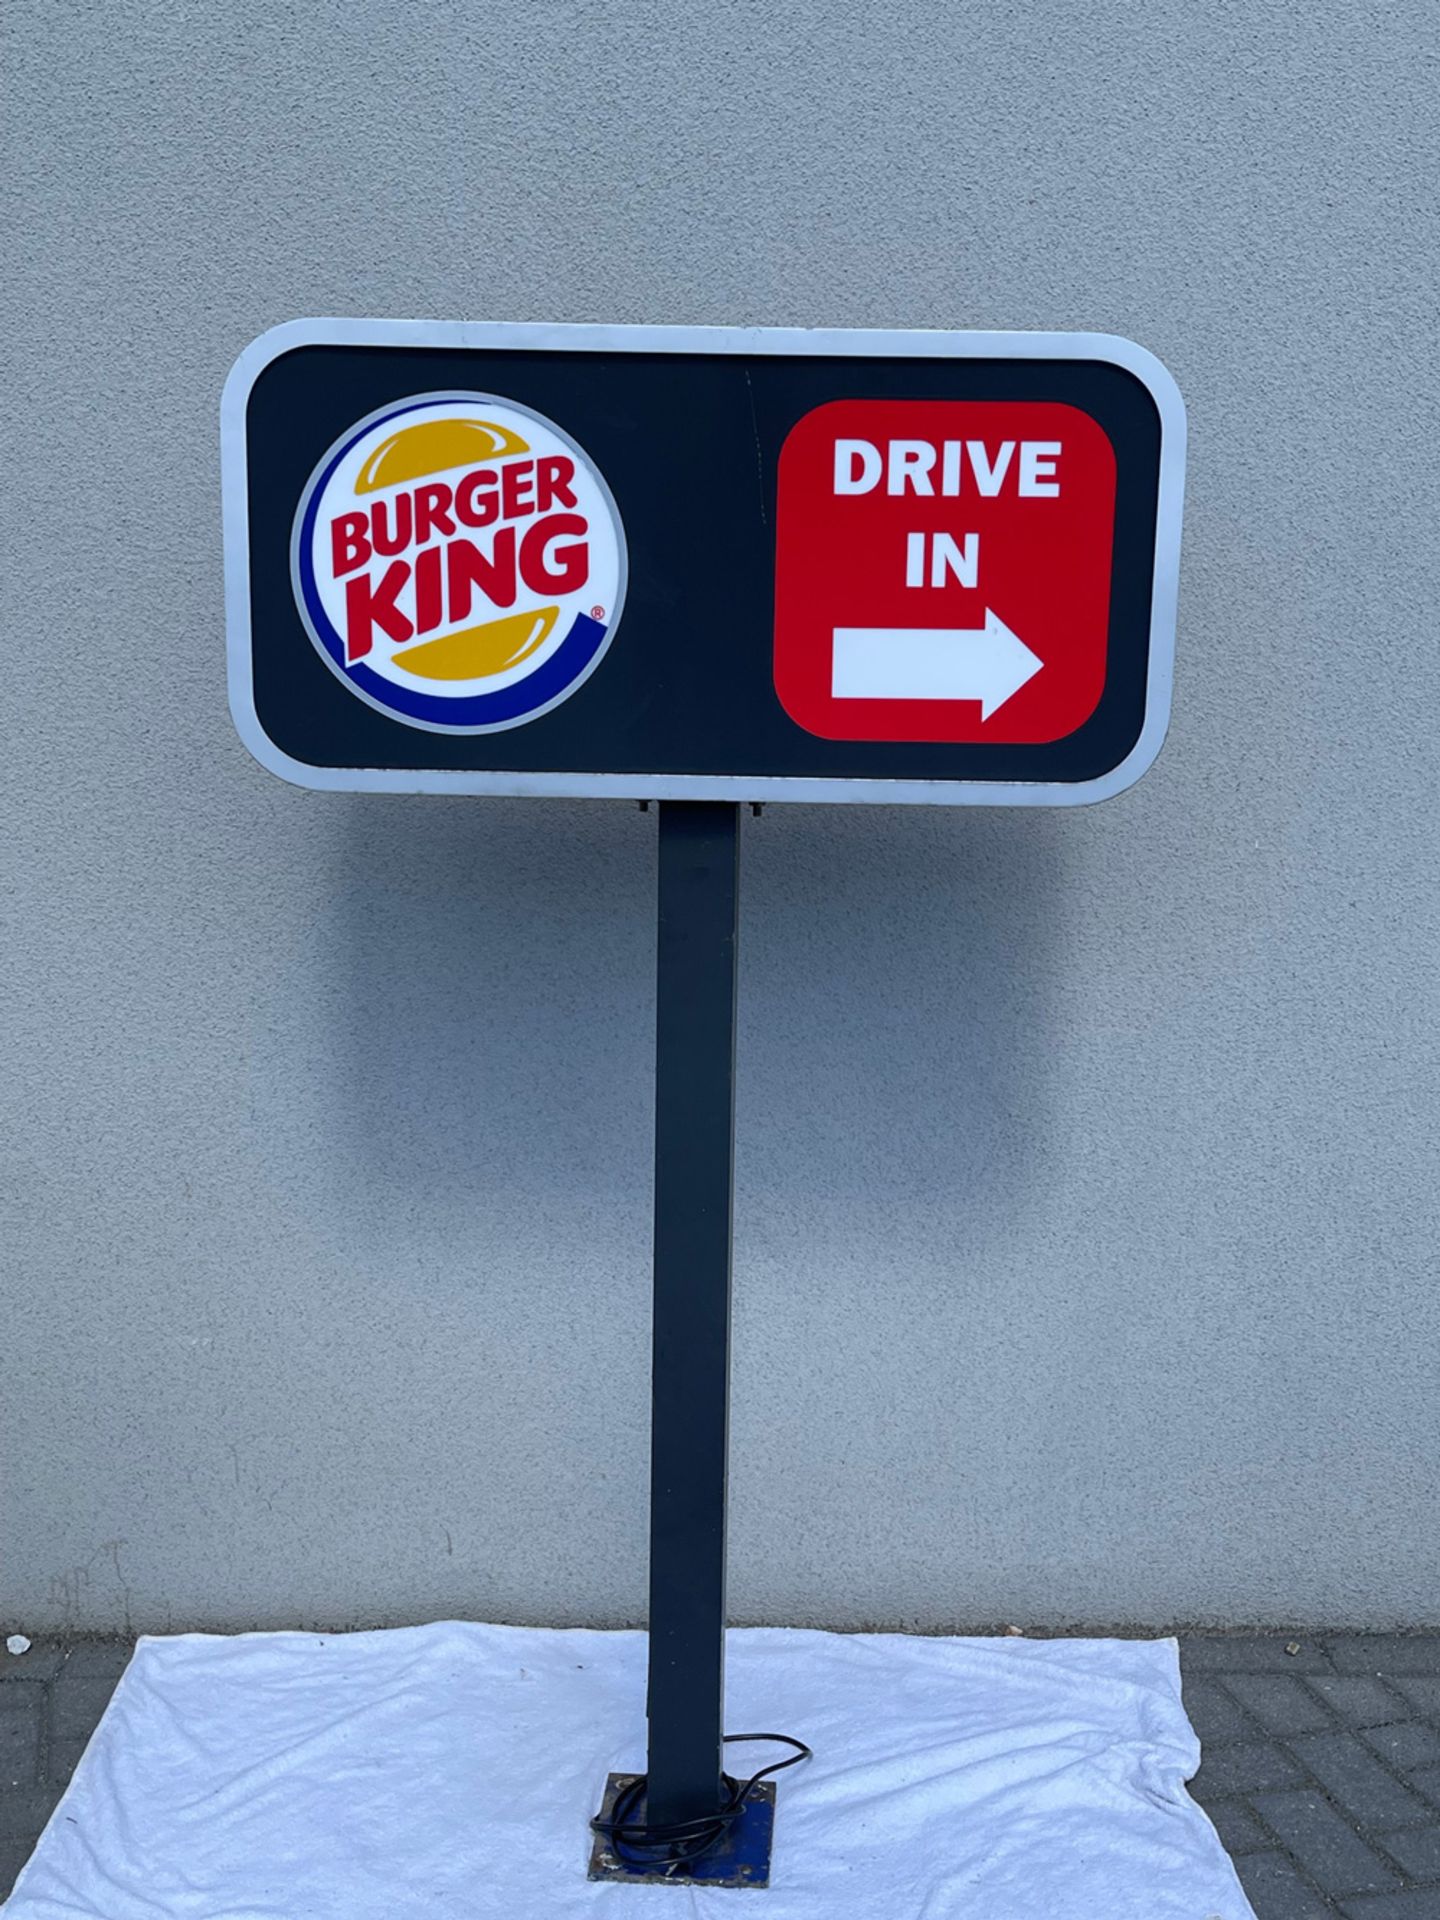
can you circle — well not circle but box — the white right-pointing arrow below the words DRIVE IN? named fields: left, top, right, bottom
left=829, top=609, right=1044, bottom=720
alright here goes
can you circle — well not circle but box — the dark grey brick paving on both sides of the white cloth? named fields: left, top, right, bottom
left=0, top=1634, right=1440, bottom=1920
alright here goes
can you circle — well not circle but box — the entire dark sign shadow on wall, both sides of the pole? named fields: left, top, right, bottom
left=324, top=797, right=1066, bottom=1265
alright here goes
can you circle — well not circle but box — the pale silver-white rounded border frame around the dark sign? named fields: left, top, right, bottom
left=221, top=319, right=1185, bottom=806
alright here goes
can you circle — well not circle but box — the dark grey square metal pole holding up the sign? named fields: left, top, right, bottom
left=647, top=801, right=739, bottom=1826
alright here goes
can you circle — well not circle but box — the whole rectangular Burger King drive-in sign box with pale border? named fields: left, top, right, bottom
left=223, top=321, right=1185, bottom=804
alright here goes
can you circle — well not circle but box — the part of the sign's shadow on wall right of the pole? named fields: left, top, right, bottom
left=739, top=808, right=1064, bottom=1260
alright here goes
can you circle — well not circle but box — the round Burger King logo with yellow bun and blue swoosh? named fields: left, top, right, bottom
left=292, top=394, right=626, bottom=733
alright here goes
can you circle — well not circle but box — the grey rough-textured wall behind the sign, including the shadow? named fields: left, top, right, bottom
left=0, top=0, right=1440, bottom=1630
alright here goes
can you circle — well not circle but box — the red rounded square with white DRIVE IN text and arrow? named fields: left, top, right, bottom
left=774, top=399, right=1116, bottom=745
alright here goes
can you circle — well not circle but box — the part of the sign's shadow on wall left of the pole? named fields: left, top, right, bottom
left=334, top=797, right=653, bottom=1244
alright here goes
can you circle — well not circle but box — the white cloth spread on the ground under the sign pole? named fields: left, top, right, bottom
left=4, top=1624, right=1254, bottom=1920
